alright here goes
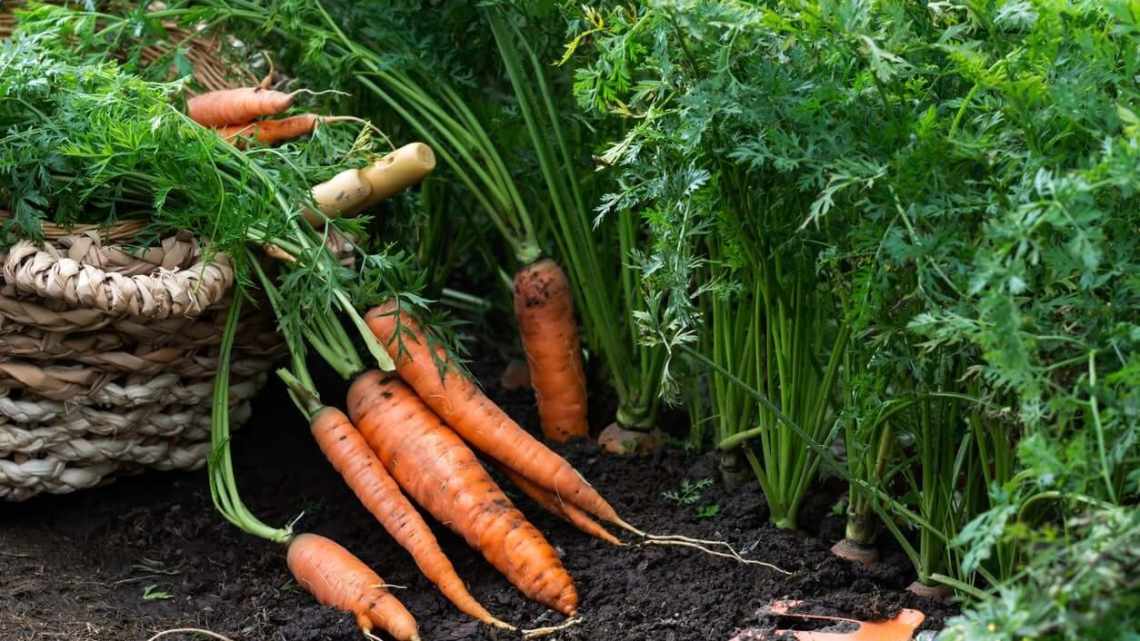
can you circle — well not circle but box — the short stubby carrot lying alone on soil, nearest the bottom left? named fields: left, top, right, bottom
left=286, top=534, right=420, bottom=641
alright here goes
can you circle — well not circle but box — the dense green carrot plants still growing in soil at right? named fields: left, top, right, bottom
left=568, top=0, right=1140, bottom=625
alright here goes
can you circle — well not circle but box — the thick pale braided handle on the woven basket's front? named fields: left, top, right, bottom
left=2, top=241, right=234, bottom=321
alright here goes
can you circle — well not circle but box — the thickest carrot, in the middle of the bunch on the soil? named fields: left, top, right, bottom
left=348, top=371, right=578, bottom=616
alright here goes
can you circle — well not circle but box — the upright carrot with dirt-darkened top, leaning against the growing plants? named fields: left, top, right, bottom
left=514, top=258, right=589, bottom=443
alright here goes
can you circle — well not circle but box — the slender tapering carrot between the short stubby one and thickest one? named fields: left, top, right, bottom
left=309, top=407, right=512, bottom=628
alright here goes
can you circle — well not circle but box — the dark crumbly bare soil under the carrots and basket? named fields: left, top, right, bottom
left=0, top=372, right=953, bottom=641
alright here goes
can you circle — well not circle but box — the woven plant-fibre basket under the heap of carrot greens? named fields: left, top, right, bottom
left=0, top=8, right=282, bottom=501
